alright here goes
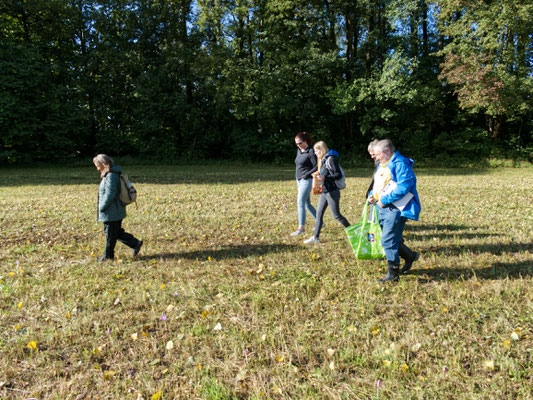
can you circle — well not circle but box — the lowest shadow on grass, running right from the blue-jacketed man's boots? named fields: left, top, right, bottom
left=409, top=261, right=533, bottom=282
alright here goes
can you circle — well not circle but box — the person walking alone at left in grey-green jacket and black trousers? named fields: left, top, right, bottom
left=93, top=154, right=143, bottom=261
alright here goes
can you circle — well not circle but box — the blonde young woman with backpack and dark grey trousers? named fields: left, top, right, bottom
left=304, top=141, right=350, bottom=244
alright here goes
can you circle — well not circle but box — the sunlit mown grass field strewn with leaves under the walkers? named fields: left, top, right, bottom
left=0, top=162, right=533, bottom=400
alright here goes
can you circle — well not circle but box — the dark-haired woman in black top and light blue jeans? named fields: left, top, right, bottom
left=291, top=132, right=317, bottom=236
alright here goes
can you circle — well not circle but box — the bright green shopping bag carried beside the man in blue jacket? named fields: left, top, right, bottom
left=346, top=203, right=385, bottom=260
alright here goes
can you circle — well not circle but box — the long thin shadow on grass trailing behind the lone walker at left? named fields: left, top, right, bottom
left=137, top=243, right=300, bottom=261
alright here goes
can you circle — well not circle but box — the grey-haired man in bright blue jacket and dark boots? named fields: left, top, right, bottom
left=368, top=139, right=421, bottom=282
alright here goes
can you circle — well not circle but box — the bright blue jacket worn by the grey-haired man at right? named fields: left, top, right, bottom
left=376, top=152, right=422, bottom=221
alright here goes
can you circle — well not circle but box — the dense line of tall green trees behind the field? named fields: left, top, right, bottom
left=0, top=0, right=533, bottom=163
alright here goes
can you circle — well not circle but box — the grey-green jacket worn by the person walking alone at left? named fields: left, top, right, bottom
left=98, top=164, right=126, bottom=222
